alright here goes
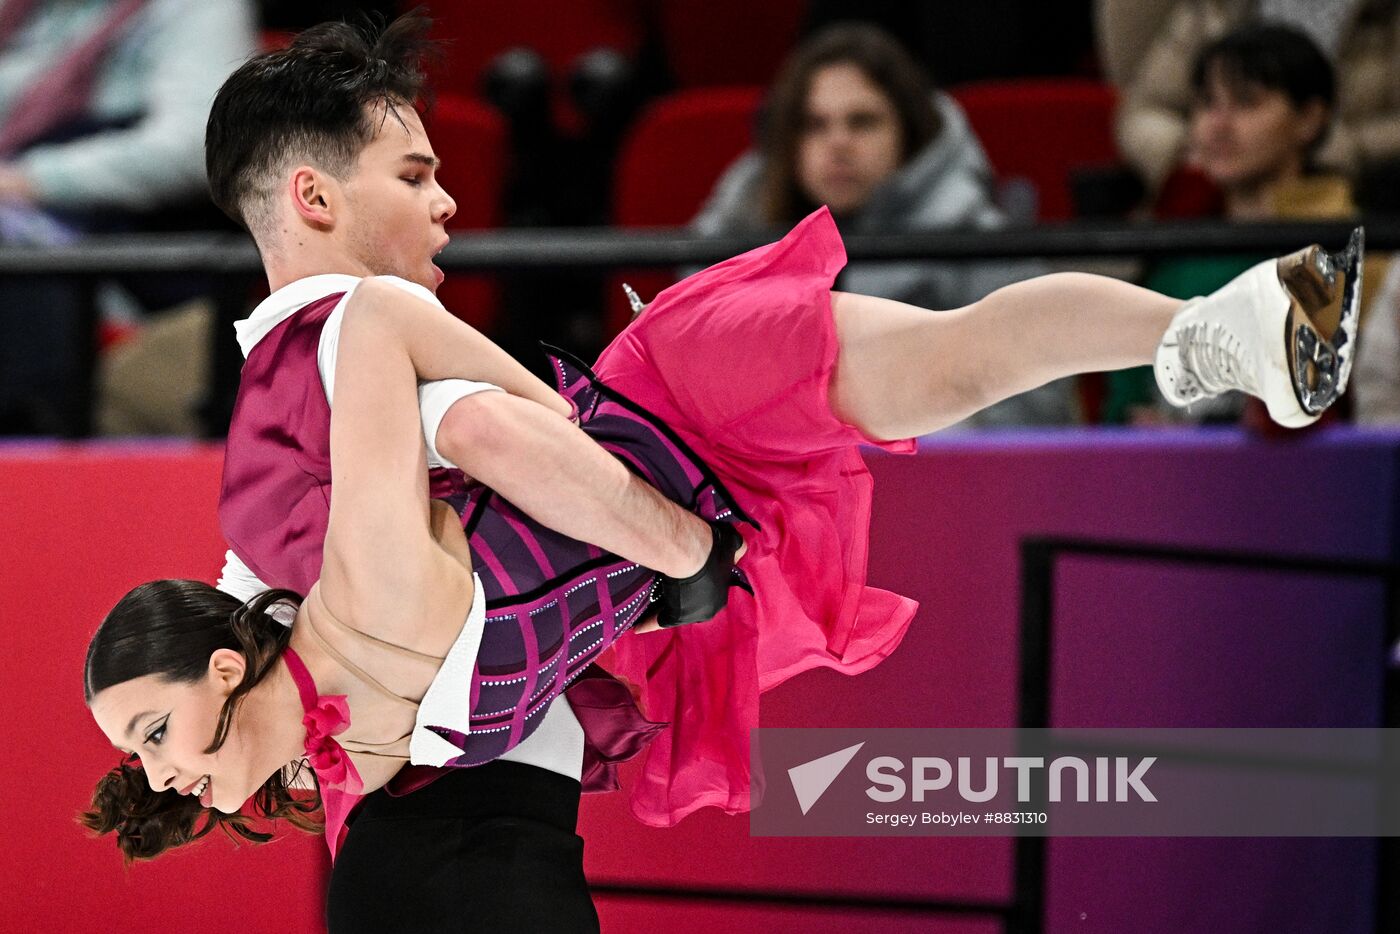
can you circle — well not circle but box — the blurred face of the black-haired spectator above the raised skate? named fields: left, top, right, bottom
left=1190, top=73, right=1326, bottom=192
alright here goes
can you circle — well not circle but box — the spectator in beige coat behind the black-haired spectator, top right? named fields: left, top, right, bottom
left=1107, top=0, right=1400, bottom=190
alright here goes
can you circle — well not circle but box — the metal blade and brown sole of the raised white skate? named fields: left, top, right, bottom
left=1278, top=227, right=1365, bottom=416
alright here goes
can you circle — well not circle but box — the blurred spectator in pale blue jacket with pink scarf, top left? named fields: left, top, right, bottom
left=0, top=0, right=255, bottom=433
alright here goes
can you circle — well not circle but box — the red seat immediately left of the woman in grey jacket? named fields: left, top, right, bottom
left=606, top=87, right=763, bottom=333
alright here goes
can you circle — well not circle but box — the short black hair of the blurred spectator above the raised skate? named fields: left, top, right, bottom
left=1191, top=22, right=1337, bottom=155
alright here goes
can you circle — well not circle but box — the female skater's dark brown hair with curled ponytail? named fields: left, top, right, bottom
left=78, top=581, right=322, bottom=863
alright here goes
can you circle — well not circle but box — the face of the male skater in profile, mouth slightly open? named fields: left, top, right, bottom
left=336, top=106, right=456, bottom=291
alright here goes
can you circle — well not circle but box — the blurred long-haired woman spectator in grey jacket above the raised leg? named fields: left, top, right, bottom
left=693, top=24, right=1074, bottom=426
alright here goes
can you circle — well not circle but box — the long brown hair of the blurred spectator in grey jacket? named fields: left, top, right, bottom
left=762, top=22, right=942, bottom=227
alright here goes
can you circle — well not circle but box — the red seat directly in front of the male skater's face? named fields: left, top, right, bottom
left=424, top=94, right=505, bottom=330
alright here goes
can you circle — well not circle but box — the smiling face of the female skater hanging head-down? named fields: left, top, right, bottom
left=91, top=648, right=270, bottom=814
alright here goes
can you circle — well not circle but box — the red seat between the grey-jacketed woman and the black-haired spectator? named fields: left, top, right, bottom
left=952, top=78, right=1120, bottom=220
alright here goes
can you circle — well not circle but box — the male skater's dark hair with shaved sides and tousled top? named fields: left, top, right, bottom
left=204, top=11, right=433, bottom=235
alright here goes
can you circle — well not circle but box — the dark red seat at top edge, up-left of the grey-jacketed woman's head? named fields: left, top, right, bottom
left=658, top=0, right=806, bottom=87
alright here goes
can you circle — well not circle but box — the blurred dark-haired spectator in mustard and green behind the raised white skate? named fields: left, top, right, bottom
left=1103, top=24, right=1385, bottom=424
